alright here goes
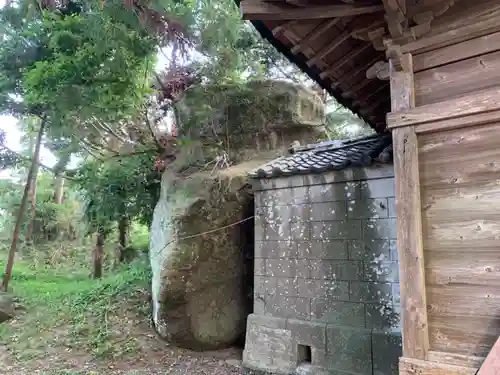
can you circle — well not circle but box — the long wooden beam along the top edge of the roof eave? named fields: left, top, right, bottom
left=240, top=0, right=384, bottom=21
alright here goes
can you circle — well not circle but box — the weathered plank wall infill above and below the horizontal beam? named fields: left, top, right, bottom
left=414, top=15, right=500, bottom=360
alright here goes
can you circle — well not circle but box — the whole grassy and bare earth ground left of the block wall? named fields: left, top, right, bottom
left=0, top=245, right=250, bottom=375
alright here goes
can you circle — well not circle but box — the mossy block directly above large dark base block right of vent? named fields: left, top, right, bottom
left=311, top=298, right=365, bottom=327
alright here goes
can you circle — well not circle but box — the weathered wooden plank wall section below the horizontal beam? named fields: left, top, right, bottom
left=419, top=123, right=500, bottom=357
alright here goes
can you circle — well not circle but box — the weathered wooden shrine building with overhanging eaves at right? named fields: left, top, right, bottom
left=239, top=0, right=500, bottom=375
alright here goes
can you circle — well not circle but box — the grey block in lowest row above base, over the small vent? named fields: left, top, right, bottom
left=265, top=295, right=311, bottom=320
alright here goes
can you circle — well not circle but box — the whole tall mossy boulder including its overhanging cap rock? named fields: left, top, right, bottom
left=150, top=81, right=325, bottom=350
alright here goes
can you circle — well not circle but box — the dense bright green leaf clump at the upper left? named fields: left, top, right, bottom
left=23, top=12, right=154, bottom=121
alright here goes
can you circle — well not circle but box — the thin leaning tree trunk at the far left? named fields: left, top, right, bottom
left=2, top=118, right=47, bottom=292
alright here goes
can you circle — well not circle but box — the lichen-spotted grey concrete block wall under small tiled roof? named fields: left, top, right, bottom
left=244, top=165, right=401, bottom=375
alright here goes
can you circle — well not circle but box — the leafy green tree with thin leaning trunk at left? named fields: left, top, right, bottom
left=0, top=1, right=165, bottom=289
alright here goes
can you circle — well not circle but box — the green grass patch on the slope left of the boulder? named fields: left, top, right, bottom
left=0, top=244, right=150, bottom=361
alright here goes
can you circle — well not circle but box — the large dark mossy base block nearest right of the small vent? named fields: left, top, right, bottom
left=326, top=324, right=372, bottom=375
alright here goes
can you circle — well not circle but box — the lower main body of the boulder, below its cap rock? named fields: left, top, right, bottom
left=150, top=161, right=262, bottom=350
